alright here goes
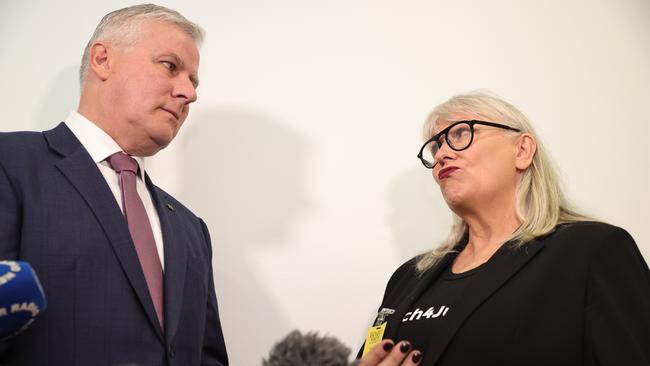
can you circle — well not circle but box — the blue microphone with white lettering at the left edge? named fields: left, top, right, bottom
left=0, top=261, right=47, bottom=340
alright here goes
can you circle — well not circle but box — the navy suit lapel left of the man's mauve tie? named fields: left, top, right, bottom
left=43, top=123, right=163, bottom=340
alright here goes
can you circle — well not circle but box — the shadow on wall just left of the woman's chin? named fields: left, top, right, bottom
left=388, top=168, right=452, bottom=263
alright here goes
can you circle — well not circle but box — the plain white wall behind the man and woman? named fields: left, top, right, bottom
left=0, top=0, right=650, bottom=366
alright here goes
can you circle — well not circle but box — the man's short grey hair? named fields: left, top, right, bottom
left=79, top=4, right=204, bottom=87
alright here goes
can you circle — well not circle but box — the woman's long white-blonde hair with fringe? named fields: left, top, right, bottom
left=416, top=92, right=590, bottom=273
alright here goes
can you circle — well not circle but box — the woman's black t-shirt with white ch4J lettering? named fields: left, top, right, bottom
left=391, top=263, right=485, bottom=349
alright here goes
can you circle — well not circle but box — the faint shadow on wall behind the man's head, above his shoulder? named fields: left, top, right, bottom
left=32, top=66, right=79, bottom=131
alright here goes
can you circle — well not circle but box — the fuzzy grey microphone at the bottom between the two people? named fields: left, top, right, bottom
left=262, top=330, right=356, bottom=366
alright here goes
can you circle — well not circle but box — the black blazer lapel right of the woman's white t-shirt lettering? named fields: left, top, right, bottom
left=425, top=240, right=544, bottom=365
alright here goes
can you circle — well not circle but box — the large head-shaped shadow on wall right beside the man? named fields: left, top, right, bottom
left=179, top=110, right=308, bottom=365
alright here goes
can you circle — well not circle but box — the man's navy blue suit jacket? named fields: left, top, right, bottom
left=0, top=123, right=228, bottom=366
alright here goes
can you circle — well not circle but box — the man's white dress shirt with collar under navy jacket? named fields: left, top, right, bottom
left=65, top=111, right=165, bottom=270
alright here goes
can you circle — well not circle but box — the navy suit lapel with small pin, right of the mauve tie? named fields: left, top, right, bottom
left=145, top=179, right=187, bottom=339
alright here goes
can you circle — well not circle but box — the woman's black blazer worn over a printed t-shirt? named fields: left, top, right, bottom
left=362, top=222, right=650, bottom=366
